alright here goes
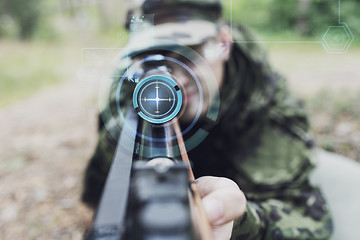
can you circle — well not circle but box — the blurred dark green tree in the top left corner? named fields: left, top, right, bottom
left=0, top=0, right=41, bottom=40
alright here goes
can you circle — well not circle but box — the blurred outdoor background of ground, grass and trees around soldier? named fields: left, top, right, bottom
left=0, top=0, right=360, bottom=239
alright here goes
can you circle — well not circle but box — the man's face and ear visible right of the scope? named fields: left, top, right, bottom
left=165, top=38, right=228, bottom=121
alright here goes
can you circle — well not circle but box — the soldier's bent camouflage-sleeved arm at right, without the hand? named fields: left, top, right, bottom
left=228, top=118, right=332, bottom=240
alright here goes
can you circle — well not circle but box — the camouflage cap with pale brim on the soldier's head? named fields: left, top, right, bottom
left=127, top=0, right=222, bottom=54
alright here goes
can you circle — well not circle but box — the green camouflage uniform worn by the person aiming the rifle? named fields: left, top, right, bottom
left=83, top=0, right=332, bottom=240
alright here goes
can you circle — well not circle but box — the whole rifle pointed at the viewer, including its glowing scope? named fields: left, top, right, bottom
left=87, top=58, right=212, bottom=240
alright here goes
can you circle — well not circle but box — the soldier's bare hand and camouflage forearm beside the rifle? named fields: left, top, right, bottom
left=197, top=169, right=332, bottom=240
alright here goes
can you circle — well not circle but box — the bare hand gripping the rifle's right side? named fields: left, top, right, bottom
left=197, top=177, right=246, bottom=240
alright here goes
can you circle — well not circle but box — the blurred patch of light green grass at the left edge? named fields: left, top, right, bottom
left=0, top=41, right=70, bottom=108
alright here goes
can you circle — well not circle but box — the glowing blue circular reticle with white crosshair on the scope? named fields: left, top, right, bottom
left=133, top=75, right=182, bottom=124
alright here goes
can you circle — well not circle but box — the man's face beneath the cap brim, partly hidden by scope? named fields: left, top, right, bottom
left=131, top=27, right=232, bottom=122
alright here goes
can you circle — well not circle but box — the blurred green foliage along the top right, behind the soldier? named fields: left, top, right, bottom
left=224, top=0, right=360, bottom=40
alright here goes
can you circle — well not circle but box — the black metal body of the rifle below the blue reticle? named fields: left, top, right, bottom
left=88, top=111, right=197, bottom=240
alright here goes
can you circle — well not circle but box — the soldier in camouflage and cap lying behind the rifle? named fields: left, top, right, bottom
left=83, top=0, right=332, bottom=240
